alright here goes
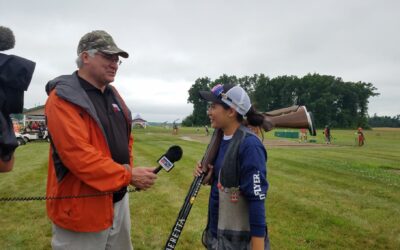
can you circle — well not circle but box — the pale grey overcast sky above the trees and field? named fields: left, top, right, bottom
left=0, top=0, right=400, bottom=122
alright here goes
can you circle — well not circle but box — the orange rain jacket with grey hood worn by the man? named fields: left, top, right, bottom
left=45, top=72, right=133, bottom=232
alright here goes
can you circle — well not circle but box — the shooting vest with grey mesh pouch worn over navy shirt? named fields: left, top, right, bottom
left=202, top=126, right=269, bottom=250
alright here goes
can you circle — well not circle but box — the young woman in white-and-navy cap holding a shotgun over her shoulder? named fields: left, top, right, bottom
left=195, top=84, right=269, bottom=250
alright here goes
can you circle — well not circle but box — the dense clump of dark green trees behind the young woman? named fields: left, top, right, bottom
left=182, top=74, right=379, bottom=128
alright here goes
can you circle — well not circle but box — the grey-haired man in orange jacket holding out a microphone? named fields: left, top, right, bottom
left=45, top=30, right=156, bottom=249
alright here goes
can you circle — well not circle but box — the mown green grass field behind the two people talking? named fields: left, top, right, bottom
left=0, top=128, right=400, bottom=250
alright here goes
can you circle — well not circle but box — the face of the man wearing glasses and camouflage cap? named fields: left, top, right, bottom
left=85, top=52, right=120, bottom=86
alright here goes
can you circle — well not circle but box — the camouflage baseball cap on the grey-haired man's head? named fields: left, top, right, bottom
left=78, top=30, right=129, bottom=58
